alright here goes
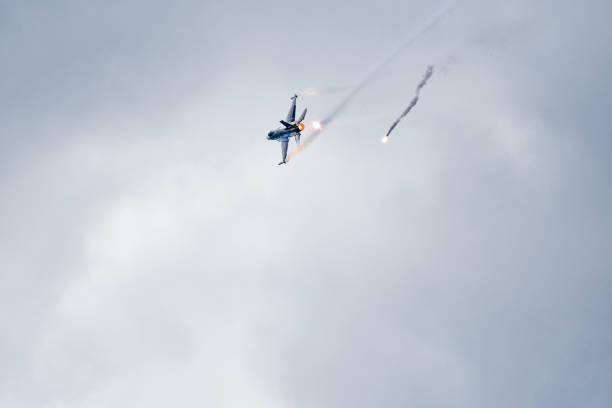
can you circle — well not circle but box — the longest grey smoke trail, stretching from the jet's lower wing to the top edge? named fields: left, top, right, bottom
left=287, top=0, right=458, bottom=161
